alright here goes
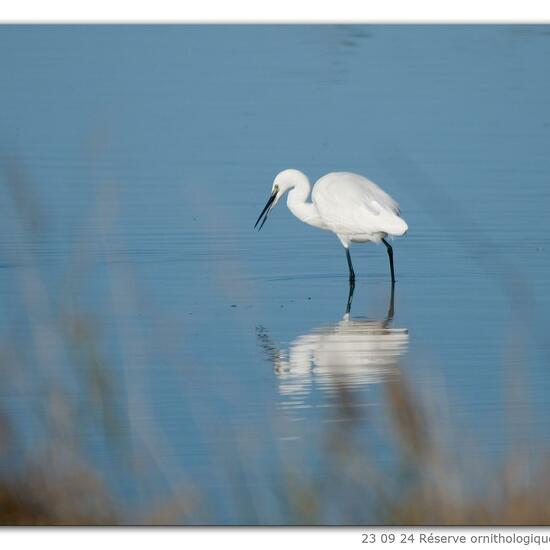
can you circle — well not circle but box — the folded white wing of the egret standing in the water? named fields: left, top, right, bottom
left=312, top=172, right=406, bottom=235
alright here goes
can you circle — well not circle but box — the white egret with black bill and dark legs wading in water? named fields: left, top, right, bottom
left=254, top=169, right=408, bottom=286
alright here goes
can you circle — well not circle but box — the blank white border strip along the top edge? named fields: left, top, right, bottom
left=0, top=0, right=550, bottom=23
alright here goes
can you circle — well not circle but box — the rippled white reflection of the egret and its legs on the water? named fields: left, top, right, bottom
left=258, top=285, right=409, bottom=408
